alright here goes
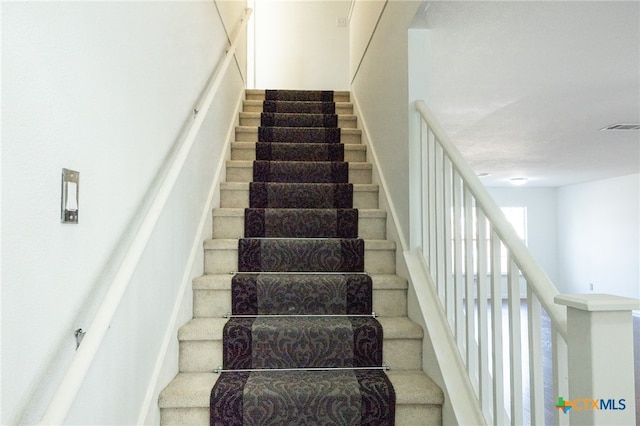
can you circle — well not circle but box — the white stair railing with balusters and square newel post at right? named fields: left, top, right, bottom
left=409, top=101, right=638, bottom=425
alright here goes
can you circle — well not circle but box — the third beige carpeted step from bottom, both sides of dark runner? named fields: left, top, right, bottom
left=192, top=274, right=407, bottom=318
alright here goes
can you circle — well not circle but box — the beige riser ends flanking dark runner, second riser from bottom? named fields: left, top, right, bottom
left=179, top=335, right=422, bottom=373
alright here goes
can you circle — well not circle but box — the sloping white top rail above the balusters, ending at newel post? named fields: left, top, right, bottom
left=416, top=100, right=567, bottom=340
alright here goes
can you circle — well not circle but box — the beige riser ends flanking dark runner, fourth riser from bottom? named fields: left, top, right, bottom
left=204, top=245, right=396, bottom=274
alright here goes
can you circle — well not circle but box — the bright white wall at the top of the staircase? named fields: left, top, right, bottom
left=255, top=0, right=351, bottom=90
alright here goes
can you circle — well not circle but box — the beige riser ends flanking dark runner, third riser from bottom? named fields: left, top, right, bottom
left=193, top=289, right=407, bottom=318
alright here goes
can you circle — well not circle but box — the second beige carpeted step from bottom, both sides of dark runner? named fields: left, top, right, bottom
left=178, top=317, right=423, bottom=372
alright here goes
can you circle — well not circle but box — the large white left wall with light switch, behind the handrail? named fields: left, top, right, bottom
left=0, top=1, right=243, bottom=424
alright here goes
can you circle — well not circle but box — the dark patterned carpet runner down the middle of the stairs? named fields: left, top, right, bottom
left=210, top=90, right=395, bottom=426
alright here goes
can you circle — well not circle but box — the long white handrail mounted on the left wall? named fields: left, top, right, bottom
left=40, top=9, right=252, bottom=425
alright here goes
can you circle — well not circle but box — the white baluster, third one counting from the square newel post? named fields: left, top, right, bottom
left=507, top=256, right=524, bottom=426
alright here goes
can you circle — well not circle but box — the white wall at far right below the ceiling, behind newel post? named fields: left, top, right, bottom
left=558, top=174, right=640, bottom=298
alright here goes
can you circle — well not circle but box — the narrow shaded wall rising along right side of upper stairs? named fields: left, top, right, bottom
left=350, top=1, right=420, bottom=250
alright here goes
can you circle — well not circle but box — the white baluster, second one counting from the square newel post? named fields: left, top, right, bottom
left=527, top=285, right=544, bottom=425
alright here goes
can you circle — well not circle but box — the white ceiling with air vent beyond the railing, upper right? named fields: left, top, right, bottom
left=421, top=1, right=640, bottom=186
